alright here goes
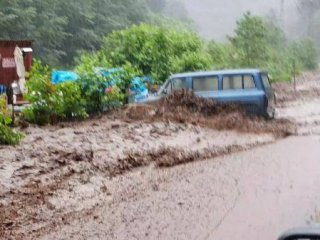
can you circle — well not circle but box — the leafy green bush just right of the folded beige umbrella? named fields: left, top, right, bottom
left=23, top=60, right=87, bottom=125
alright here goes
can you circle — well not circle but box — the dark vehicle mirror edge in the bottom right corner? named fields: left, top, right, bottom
left=279, top=228, right=320, bottom=240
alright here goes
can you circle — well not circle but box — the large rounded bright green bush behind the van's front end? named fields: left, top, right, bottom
left=77, top=24, right=211, bottom=82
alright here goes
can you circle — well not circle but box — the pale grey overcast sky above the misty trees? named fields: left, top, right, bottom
left=184, top=0, right=297, bottom=40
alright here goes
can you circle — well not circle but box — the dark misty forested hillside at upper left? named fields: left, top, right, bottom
left=0, top=0, right=189, bottom=66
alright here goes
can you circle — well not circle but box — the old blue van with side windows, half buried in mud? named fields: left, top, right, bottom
left=142, top=69, right=275, bottom=118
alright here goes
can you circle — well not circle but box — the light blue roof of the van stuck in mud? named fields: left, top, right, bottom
left=171, top=69, right=265, bottom=78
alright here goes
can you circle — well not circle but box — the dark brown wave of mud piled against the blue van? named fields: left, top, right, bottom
left=120, top=91, right=296, bottom=137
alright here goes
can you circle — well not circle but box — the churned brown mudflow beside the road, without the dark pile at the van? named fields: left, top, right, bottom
left=0, top=116, right=277, bottom=239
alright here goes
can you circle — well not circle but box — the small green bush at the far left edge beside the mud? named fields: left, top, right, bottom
left=0, top=95, right=23, bottom=145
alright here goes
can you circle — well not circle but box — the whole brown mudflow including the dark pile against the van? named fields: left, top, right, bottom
left=0, top=89, right=295, bottom=239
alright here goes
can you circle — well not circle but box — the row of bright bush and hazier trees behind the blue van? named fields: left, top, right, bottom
left=77, top=12, right=318, bottom=82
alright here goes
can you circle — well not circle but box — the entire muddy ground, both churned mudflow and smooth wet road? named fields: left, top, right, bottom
left=0, top=72, right=320, bottom=240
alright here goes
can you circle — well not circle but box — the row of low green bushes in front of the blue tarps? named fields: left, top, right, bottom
left=23, top=60, right=139, bottom=125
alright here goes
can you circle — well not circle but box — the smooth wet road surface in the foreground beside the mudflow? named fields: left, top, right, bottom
left=42, top=136, right=320, bottom=240
